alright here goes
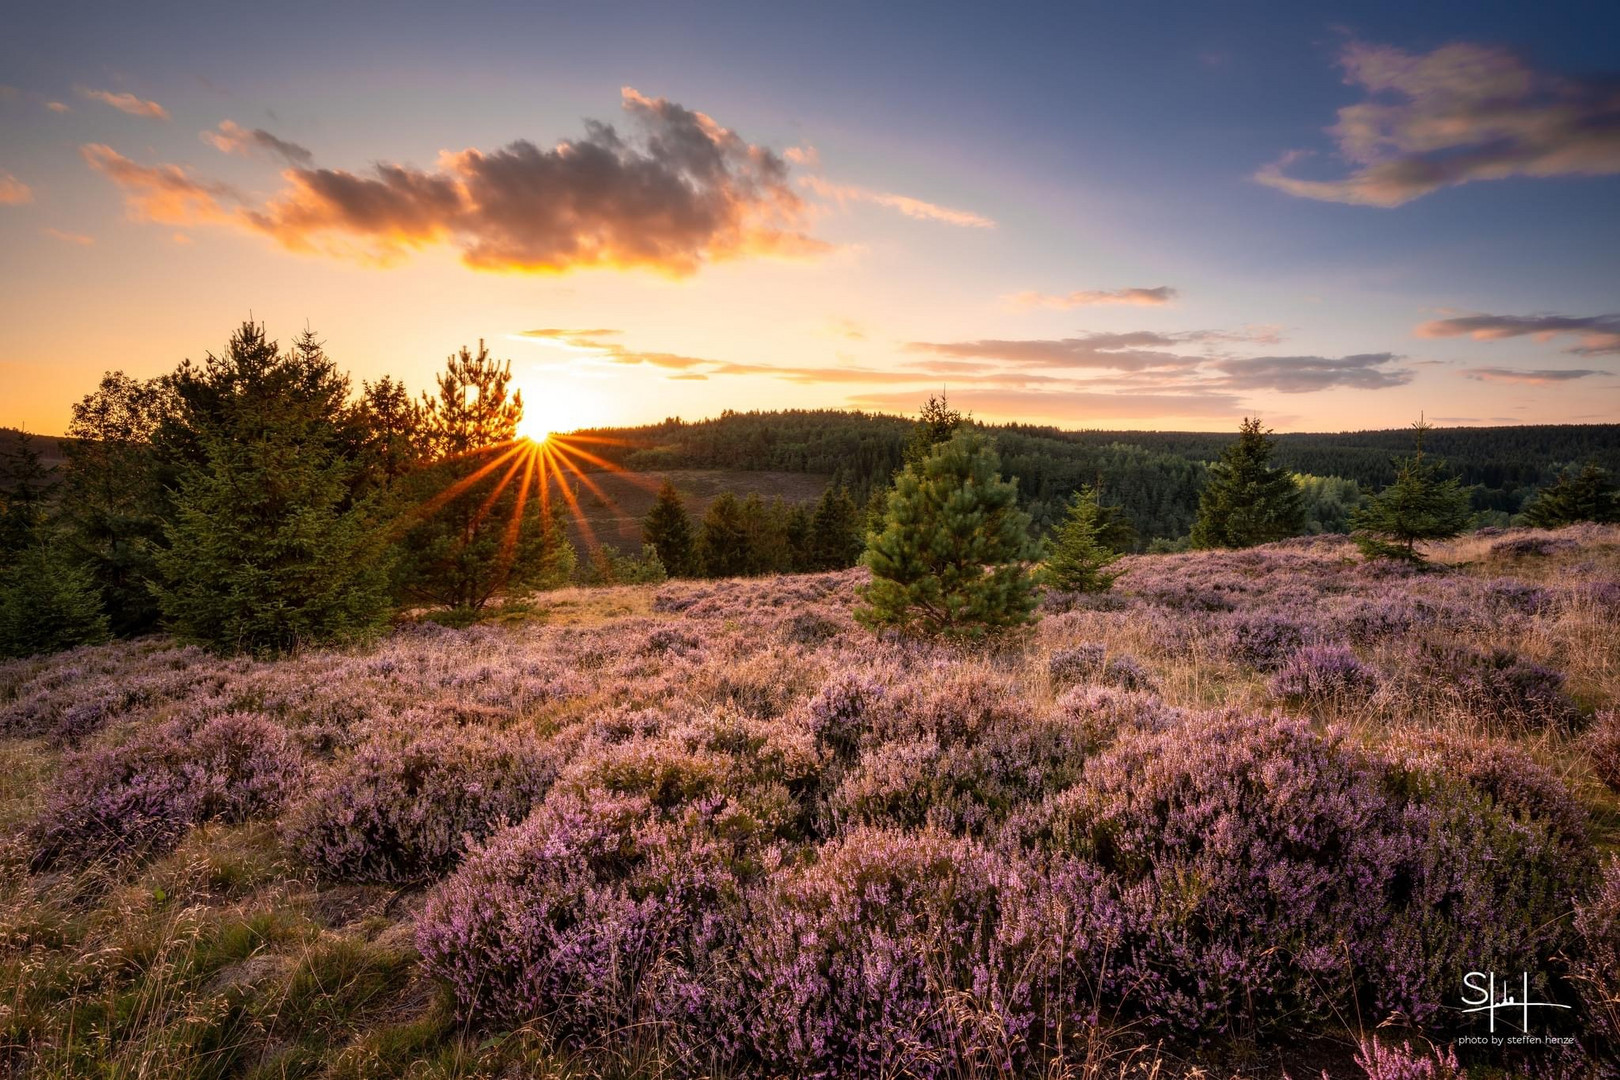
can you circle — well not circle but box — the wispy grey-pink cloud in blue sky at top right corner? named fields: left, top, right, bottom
left=1254, top=42, right=1620, bottom=207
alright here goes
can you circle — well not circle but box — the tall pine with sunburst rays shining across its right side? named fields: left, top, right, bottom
left=399, top=342, right=577, bottom=612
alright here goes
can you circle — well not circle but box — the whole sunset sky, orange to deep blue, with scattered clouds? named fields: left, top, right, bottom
left=0, top=0, right=1620, bottom=434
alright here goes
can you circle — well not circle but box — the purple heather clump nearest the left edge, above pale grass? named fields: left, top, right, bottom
left=34, top=712, right=303, bottom=866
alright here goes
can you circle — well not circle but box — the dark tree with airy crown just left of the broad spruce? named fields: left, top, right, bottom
left=62, top=371, right=177, bottom=636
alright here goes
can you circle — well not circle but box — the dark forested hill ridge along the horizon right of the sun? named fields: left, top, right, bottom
left=580, top=410, right=1620, bottom=542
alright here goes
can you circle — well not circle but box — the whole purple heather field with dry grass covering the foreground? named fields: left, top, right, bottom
left=0, top=526, right=1620, bottom=1080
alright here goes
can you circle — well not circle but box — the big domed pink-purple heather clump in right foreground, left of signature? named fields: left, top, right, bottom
left=1021, top=716, right=1398, bottom=1033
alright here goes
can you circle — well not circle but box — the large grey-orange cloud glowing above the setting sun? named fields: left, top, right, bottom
left=234, top=87, right=826, bottom=275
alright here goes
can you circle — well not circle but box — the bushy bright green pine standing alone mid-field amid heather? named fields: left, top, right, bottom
left=855, top=432, right=1040, bottom=638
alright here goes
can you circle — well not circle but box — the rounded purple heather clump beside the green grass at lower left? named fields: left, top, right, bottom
left=416, top=792, right=739, bottom=1046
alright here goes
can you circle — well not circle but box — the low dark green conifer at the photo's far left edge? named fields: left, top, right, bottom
left=0, top=542, right=107, bottom=656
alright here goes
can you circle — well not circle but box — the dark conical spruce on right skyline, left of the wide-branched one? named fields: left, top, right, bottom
left=1192, top=418, right=1304, bottom=547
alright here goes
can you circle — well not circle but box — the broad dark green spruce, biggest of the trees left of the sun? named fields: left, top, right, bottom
left=156, top=324, right=387, bottom=653
